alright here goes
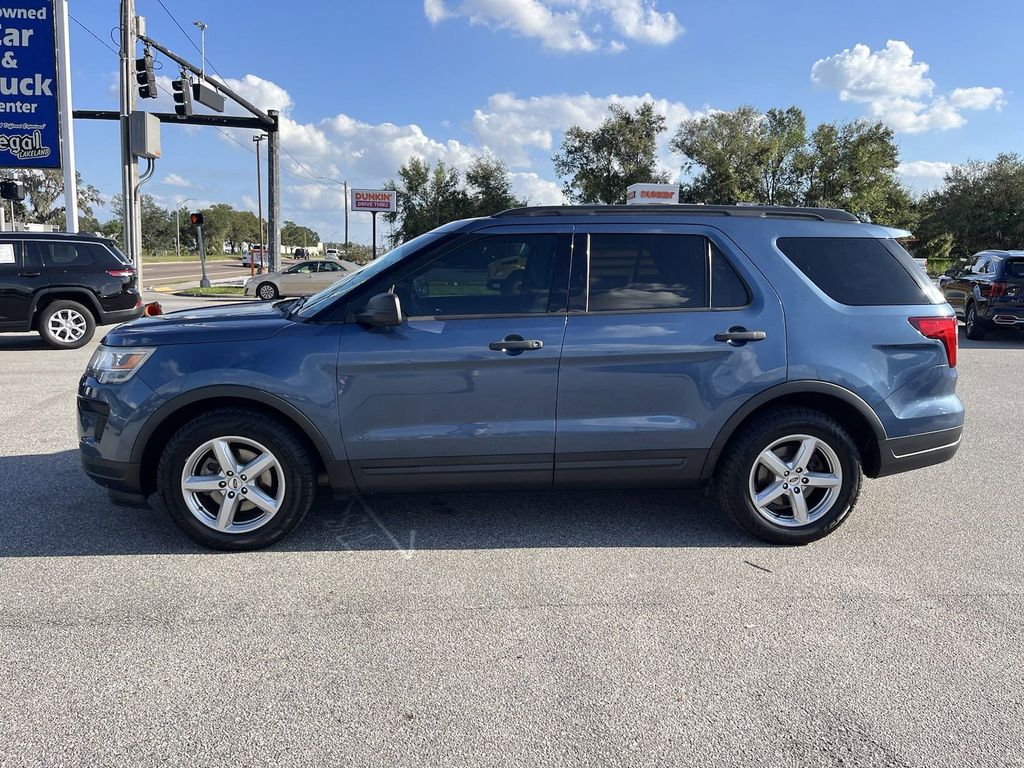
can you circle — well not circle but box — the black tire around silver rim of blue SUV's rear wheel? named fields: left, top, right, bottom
left=718, top=408, right=862, bottom=545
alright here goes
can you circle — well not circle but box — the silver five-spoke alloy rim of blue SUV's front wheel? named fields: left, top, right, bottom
left=181, top=436, right=286, bottom=534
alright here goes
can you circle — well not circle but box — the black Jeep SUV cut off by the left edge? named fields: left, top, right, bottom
left=0, top=232, right=142, bottom=349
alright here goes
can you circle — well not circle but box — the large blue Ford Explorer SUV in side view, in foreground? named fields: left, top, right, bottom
left=78, top=206, right=964, bottom=549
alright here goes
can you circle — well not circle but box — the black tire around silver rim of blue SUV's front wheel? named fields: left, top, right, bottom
left=157, top=409, right=316, bottom=551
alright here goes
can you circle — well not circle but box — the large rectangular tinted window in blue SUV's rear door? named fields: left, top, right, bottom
left=588, top=234, right=708, bottom=312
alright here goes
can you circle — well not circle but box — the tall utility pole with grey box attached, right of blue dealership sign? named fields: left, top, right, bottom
left=121, top=0, right=142, bottom=290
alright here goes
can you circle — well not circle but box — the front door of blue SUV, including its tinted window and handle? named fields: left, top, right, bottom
left=338, top=227, right=571, bottom=492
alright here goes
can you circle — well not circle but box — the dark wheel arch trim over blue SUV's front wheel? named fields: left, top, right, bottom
left=131, top=385, right=352, bottom=495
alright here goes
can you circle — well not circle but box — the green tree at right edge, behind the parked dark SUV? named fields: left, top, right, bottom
left=920, top=154, right=1024, bottom=258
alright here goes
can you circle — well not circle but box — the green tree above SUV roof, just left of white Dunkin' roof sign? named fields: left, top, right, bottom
left=552, top=102, right=669, bottom=205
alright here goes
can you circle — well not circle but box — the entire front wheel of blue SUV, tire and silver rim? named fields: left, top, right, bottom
left=157, top=410, right=316, bottom=550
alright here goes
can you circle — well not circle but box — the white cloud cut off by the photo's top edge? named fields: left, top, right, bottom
left=423, top=0, right=683, bottom=53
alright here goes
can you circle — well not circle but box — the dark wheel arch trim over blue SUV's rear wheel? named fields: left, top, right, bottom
left=700, top=381, right=887, bottom=481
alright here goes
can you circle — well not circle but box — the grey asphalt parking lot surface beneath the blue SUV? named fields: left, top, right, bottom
left=0, top=301, right=1024, bottom=767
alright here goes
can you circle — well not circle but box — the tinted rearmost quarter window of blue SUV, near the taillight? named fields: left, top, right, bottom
left=776, top=238, right=932, bottom=306
